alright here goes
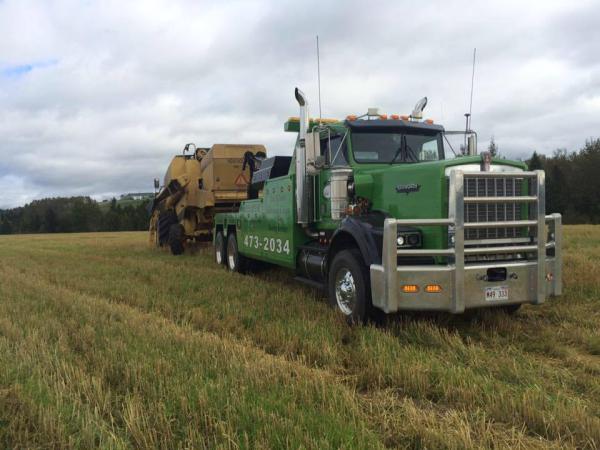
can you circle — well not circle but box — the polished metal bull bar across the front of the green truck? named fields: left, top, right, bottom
left=370, top=170, right=562, bottom=313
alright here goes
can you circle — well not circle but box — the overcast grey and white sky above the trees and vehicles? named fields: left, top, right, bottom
left=0, top=0, right=600, bottom=208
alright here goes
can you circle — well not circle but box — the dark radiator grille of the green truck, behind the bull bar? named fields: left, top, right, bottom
left=464, top=176, right=523, bottom=241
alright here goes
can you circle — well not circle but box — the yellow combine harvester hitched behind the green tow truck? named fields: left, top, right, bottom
left=150, top=144, right=266, bottom=255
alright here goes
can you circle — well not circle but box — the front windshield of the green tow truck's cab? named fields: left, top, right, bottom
left=352, top=132, right=444, bottom=163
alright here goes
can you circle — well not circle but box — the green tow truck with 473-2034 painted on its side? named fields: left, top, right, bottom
left=213, top=89, right=562, bottom=322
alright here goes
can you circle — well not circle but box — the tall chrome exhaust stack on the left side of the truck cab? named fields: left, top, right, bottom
left=294, top=88, right=311, bottom=225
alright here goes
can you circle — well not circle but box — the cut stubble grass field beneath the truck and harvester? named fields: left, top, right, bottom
left=0, top=226, right=600, bottom=449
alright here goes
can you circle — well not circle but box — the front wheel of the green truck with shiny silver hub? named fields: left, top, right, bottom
left=328, top=249, right=371, bottom=323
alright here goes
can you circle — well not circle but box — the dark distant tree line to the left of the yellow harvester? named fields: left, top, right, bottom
left=0, top=197, right=149, bottom=234
